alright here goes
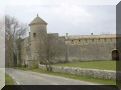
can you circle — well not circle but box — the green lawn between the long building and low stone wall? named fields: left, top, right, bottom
left=55, top=61, right=116, bottom=70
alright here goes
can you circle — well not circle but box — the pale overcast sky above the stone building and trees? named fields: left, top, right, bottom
left=0, top=0, right=120, bottom=35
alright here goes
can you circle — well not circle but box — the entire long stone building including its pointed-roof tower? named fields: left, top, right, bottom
left=21, top=16, right=121, bottom=66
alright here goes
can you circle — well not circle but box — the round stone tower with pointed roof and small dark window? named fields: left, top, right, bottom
left=29, top=15, right=47, bottom=66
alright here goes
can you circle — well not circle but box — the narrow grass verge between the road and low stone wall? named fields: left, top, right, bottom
left=15, top=68, right=116, bottom=85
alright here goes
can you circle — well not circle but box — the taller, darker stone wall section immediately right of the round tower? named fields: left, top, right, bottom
left=48, top=33, right=65, bottom=63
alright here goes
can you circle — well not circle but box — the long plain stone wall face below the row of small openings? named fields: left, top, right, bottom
left=68, top=43, right=116, bottom=61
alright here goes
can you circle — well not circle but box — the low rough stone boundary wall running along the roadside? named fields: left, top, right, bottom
left=39, top=64, right=116, bottom=80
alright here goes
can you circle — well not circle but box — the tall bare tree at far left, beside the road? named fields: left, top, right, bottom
left=5, top=15, right=27, bottom=66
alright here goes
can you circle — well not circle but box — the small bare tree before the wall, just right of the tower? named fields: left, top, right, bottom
left=45, top=36, right=65, bottom=71
